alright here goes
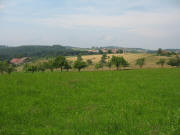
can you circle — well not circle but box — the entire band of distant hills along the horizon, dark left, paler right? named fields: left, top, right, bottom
left=0, top=45, right=180, bottom=60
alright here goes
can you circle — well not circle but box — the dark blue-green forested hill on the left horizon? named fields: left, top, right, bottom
left=0, top=45, right=87, bottom=60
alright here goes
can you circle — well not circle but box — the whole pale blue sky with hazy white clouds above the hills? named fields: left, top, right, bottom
left=0, top=0, right=180, bottom=49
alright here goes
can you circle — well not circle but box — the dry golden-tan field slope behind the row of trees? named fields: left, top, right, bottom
left=17, top=53, right=175, bottom=71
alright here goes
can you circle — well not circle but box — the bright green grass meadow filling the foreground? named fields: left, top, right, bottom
left=0, top=69, right=180, bottom=135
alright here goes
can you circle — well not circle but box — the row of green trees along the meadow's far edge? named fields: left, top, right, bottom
left=0, top=54, right=180, bottom=74
